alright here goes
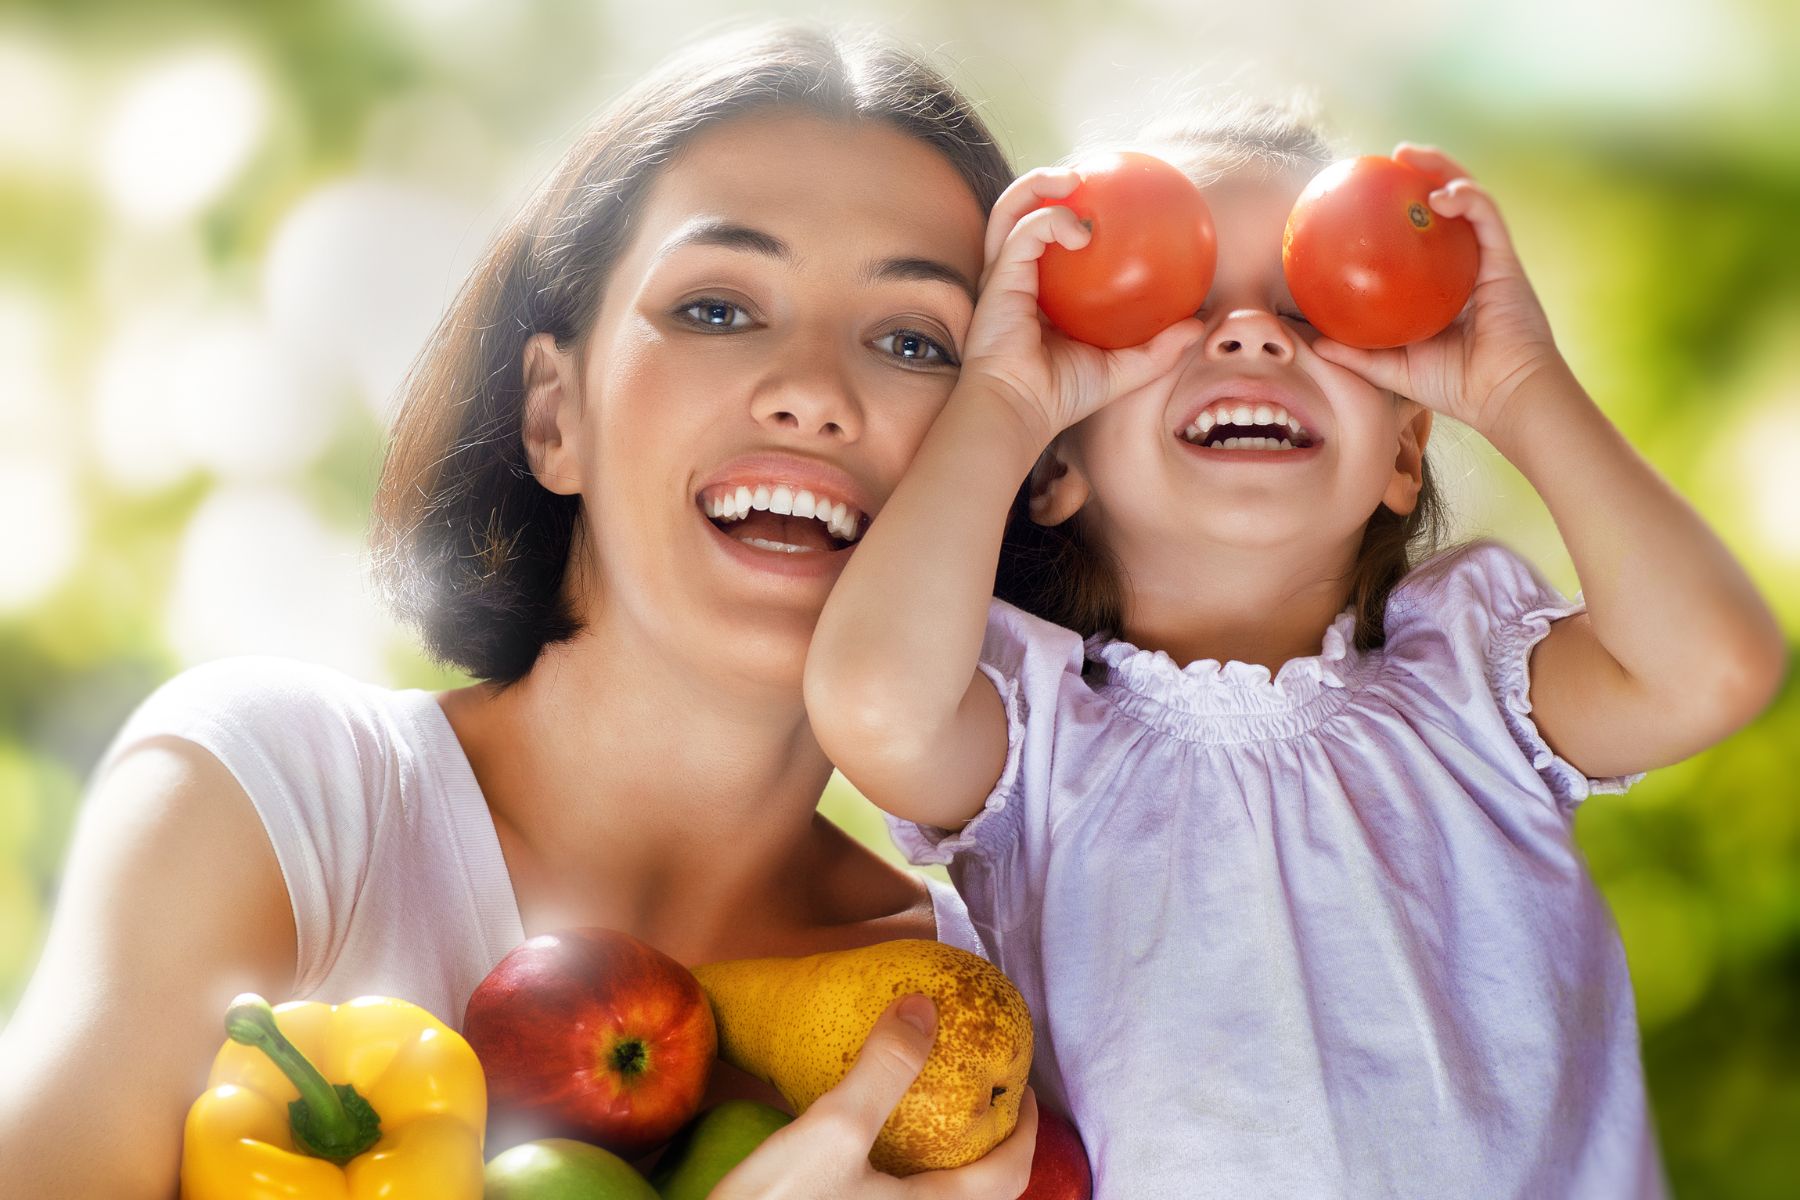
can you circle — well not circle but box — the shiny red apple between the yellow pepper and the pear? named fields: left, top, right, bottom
left=463, top=928, right=718, bottom=1159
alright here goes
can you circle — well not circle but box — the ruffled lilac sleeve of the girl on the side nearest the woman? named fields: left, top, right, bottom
left=887, top=599, right=1082, bottom=865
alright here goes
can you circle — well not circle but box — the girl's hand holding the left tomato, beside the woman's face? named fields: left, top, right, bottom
left=958, top=167, right=1204, bottom=444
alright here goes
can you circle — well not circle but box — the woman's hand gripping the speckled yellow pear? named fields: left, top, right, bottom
left=713, top=995, right=1037, bottom=1200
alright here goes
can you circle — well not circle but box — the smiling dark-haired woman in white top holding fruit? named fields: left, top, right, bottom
left=0, top=29, right=1035, bottom=1198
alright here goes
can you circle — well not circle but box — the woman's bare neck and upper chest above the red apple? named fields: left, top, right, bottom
left=443, top=628, right=832, bottom=941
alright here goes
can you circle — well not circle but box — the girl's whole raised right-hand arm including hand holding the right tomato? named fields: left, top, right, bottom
left=1314, top=146, right=1787, bottom=777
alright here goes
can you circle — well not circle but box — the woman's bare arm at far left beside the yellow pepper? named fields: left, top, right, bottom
left=0, top=738, right=295, bottom=1200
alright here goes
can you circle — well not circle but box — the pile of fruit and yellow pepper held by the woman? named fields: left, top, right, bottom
left=182, top=928, right=1091, bottom=1200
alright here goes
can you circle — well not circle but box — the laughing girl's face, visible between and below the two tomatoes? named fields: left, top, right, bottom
left=1057, top=161, right=1429, bottom=578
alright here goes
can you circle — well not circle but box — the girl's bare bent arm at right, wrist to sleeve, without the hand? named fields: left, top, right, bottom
left=1489, top=356, right=1787, bottom=777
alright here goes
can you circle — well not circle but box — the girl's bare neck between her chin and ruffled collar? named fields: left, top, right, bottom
left=1120, top=529, right=1361, bottom=673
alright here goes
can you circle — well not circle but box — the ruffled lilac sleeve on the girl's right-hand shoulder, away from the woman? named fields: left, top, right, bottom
left=1388, top=542, right=1643, bottom=810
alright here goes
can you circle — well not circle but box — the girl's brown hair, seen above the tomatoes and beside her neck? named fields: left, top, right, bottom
left=994, top=97, right=1444, bottom=649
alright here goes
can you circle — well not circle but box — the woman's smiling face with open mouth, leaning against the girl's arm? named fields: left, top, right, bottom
left=527, top=113, right=986, bottom=691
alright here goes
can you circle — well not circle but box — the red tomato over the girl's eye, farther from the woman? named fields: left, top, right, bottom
left=1282, top=155, right=1481, bottom=349
